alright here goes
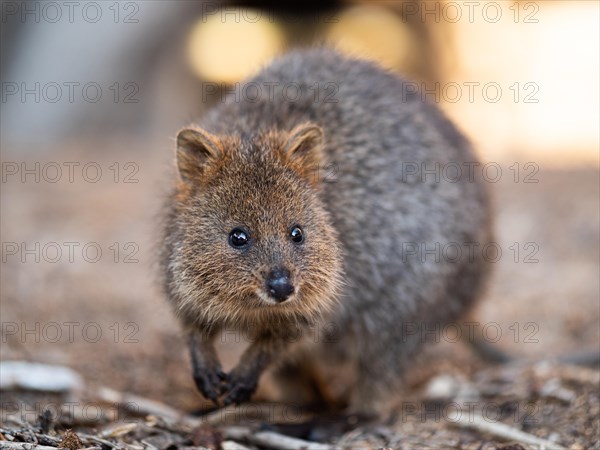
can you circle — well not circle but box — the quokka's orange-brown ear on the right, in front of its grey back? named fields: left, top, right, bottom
left=283, top=123, right=324, bottom=184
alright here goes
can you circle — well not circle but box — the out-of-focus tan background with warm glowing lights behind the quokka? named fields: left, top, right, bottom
left=0, top=0, right=600, bottom=408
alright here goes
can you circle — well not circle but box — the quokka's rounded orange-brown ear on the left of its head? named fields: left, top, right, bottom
left=177, top=128, right=223, bottom=183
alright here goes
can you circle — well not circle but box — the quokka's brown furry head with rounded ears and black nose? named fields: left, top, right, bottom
left=167, top=124, right=342, bottom=323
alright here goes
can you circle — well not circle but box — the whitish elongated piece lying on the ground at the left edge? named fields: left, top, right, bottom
left=0, top=361, right=83, bottom=392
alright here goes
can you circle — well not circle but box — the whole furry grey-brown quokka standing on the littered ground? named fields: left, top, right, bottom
left=162, top=49, right=490, bottom=413
